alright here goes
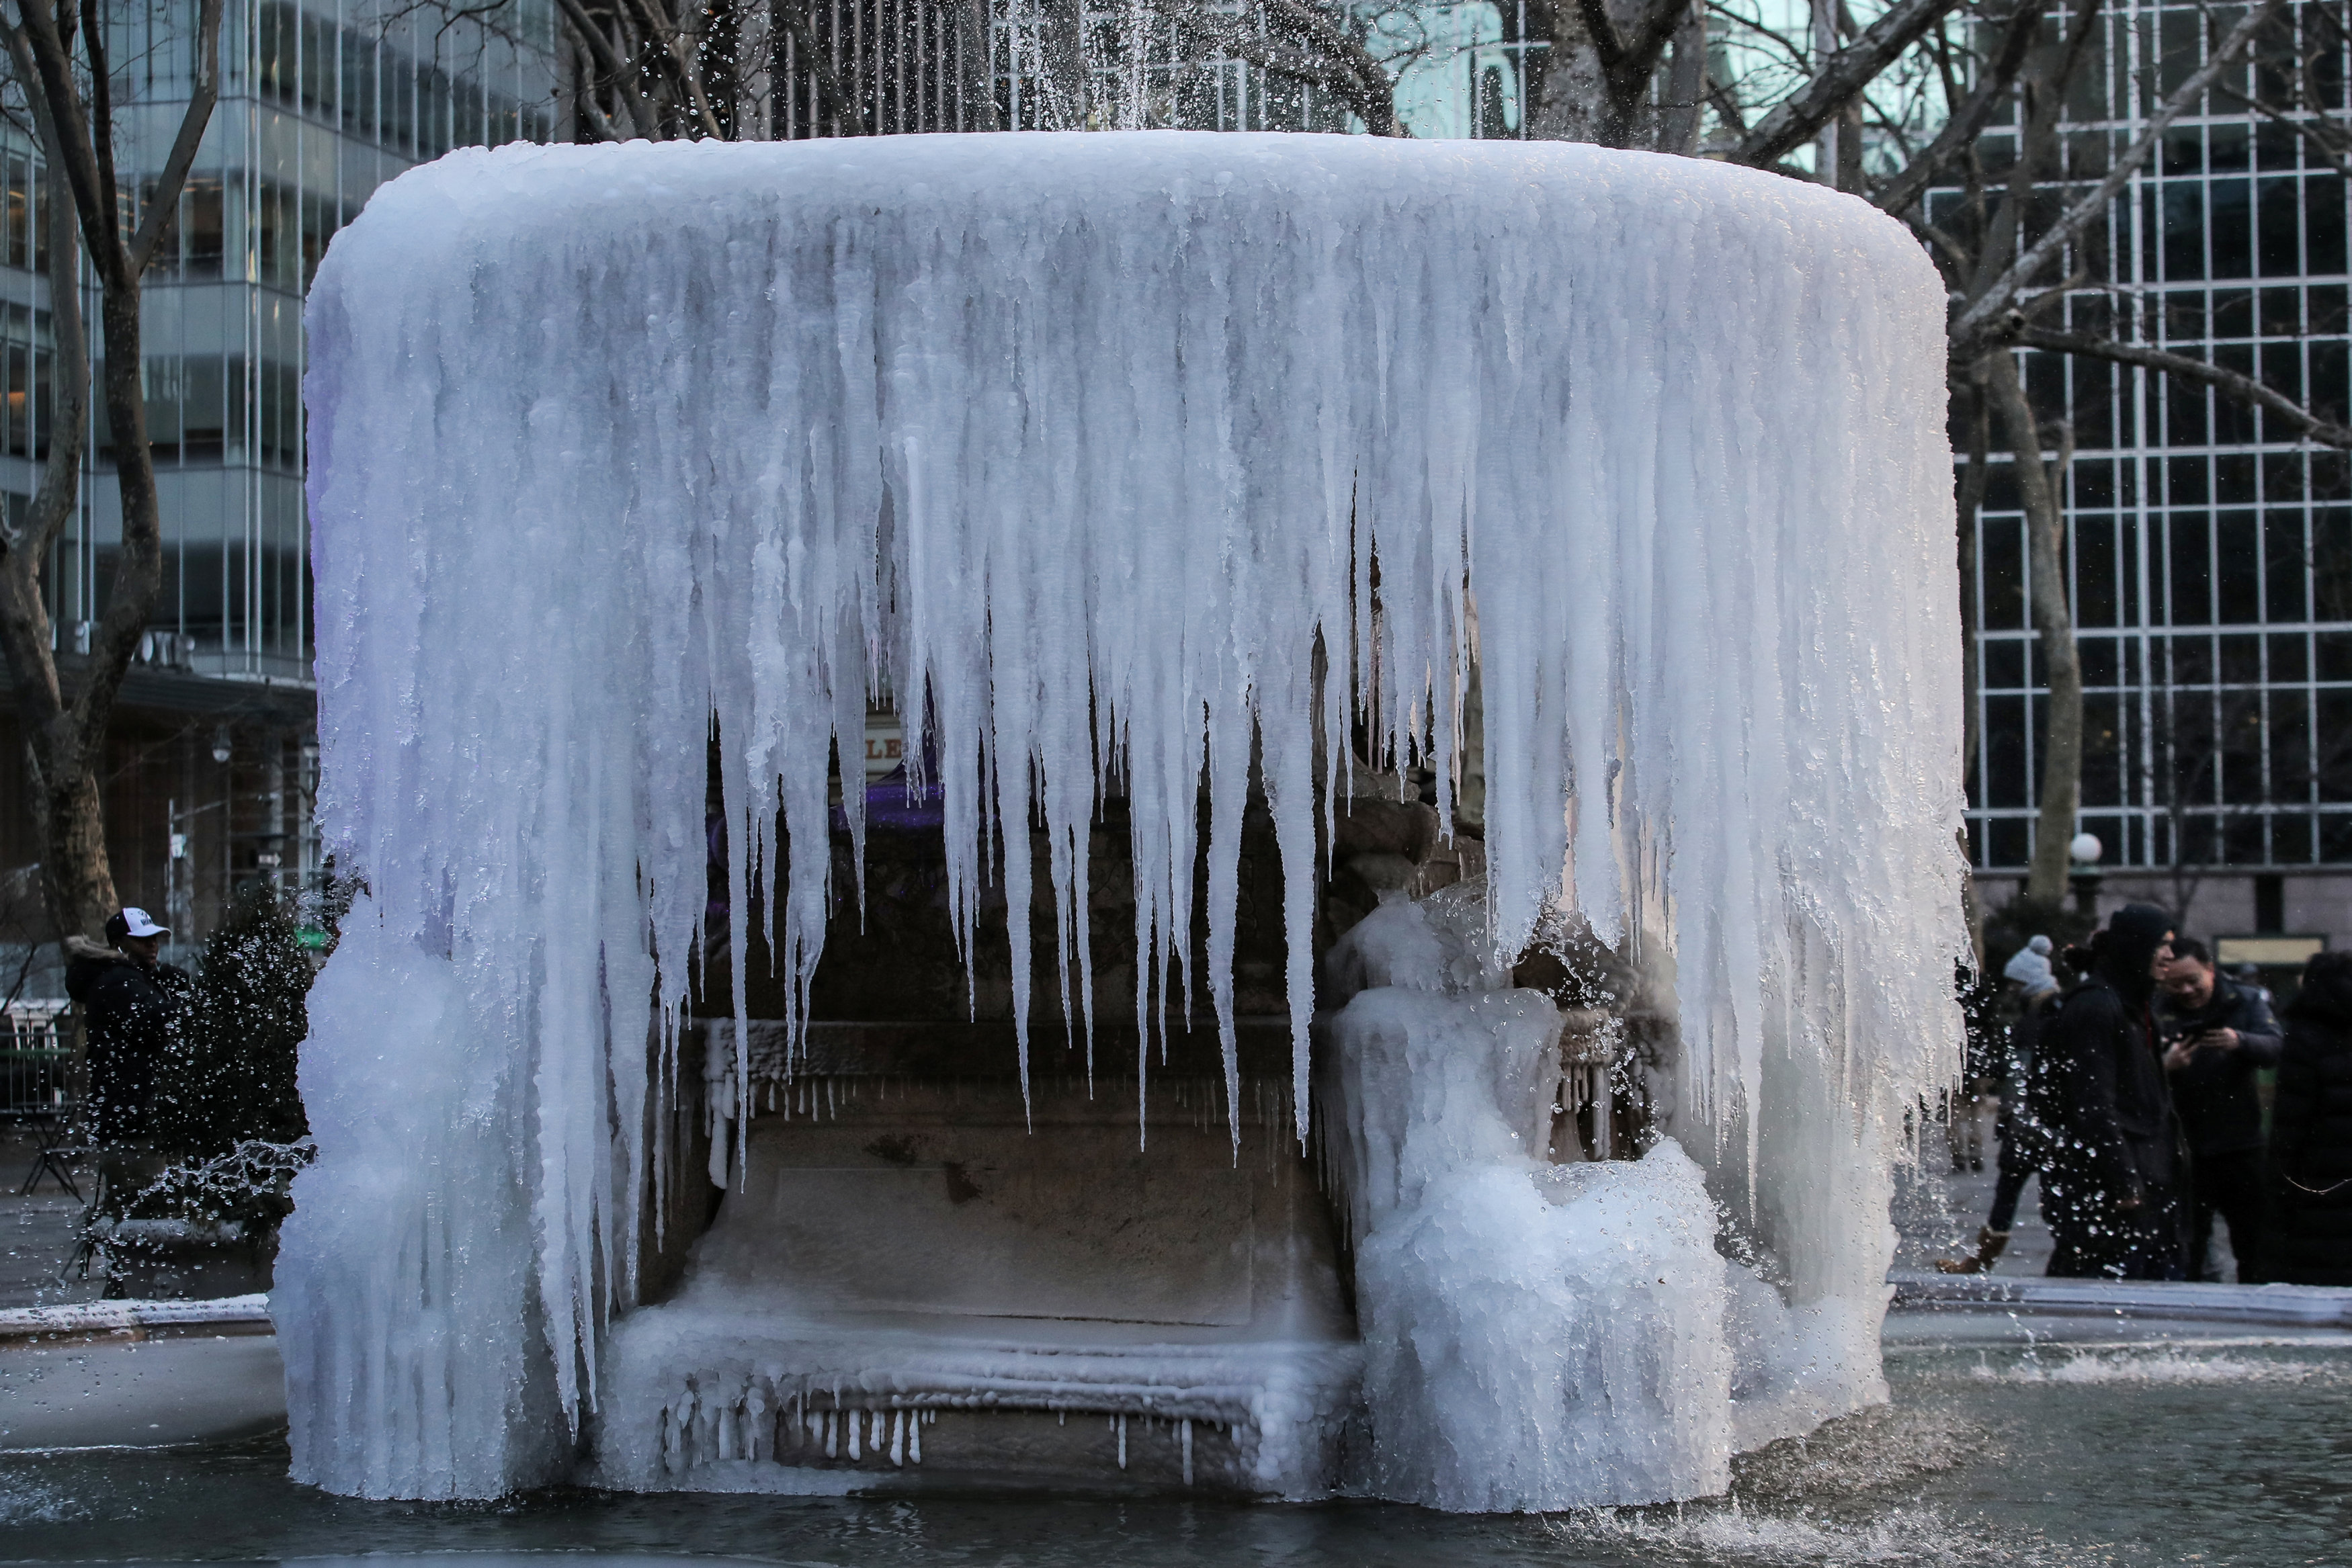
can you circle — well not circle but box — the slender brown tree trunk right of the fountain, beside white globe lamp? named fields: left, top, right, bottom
left=1985, top=353, right=2082, bottom=903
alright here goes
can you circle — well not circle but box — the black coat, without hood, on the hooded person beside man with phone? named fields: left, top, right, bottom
left=2027, top=975, right=2178, bottom=1201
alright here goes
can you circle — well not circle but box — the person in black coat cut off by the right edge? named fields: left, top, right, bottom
left=2265, top=952, right=2352, bottom=1286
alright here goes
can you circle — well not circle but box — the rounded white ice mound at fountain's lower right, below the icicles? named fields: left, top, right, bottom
left=1322, top=889, right=1884, bottom=1512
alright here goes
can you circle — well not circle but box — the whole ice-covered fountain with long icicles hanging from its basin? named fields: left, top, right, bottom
left=271, top=134, right=1964, bottom=1510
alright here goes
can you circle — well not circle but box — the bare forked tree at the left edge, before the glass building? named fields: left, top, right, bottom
left=0, top=0, right=221, bottom=936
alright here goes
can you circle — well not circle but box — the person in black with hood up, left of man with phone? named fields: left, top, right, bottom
left=2027, top=903, right=2183, bottom=1279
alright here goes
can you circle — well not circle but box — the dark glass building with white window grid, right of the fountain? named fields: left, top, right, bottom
left=1936, top=0, right=2352, bottom=961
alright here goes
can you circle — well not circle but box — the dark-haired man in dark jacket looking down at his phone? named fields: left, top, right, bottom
left=2159, top=938, right=2281, bottom=1286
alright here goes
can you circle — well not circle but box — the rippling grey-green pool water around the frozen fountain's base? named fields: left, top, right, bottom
left=0, top=1321, right=2352, bottom=1568
